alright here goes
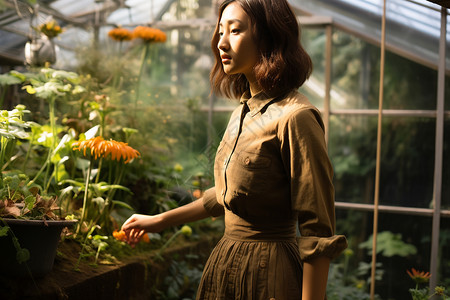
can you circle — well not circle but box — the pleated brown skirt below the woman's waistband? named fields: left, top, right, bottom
left=196, top=235, right=302, bottom=300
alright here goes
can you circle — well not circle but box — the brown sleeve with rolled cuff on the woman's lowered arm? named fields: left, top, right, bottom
left=282, top=108, right=347, bottom=261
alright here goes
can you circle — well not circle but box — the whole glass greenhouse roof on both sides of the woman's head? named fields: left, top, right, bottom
left=0, top=0, right=450, bottom=69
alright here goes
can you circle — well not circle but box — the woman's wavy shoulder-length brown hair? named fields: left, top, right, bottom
left=210, top=0, right=312, bottom=98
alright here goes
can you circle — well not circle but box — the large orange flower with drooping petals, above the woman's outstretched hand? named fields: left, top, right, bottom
left=72, top=136, right=141, bottom=164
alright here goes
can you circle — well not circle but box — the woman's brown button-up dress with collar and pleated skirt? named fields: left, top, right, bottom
left=197, top=91, right=347, bottom=300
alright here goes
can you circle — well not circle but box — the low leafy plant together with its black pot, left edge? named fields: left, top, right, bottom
left=0, top=174, right=77, bottom=277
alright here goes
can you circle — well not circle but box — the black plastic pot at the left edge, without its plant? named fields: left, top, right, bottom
left=0, top=219, right=77, bottom=278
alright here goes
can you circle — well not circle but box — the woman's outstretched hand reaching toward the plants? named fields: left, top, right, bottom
left=122, top=214, right=164, bottom=247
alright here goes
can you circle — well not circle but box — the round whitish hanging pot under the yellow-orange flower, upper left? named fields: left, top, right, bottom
left=25, top=34, right=58, bottom=67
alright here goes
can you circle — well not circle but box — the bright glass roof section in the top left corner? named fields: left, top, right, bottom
left=0, top=0, right=172, bottom=65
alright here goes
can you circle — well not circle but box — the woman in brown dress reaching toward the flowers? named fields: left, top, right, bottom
left=122, top=0, right=347, bottom=300
